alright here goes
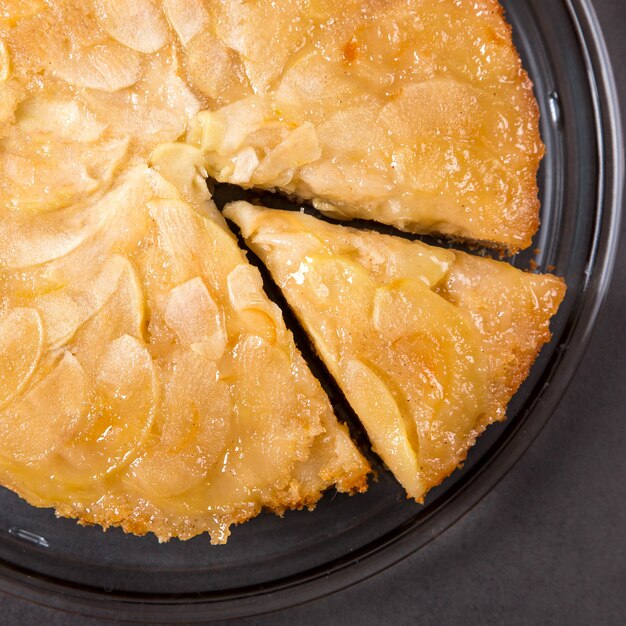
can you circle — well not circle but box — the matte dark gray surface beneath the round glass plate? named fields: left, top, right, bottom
left=0, top=0, right=626, bottom=626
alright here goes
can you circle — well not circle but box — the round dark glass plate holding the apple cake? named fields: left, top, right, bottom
left=0, top=0, right=623, bottom=623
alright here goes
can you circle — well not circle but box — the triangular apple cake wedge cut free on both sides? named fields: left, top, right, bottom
left=225, top=202, right=565, bottom=502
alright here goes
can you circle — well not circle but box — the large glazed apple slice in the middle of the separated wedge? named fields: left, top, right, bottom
left=373, top=279, right=487, bottom=484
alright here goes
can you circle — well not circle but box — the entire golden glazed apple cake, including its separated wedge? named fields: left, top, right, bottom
left=0, top=0, right=564, bottom=543
